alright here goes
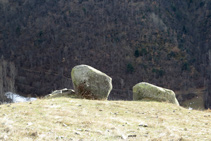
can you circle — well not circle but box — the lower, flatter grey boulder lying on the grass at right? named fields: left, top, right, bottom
left=133, top=82, right=179, bottom=105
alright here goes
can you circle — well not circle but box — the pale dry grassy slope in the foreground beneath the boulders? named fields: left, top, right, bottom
left=0, top=97, right=211, bottom=141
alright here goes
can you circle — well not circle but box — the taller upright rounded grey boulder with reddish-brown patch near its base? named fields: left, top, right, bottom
left=71, top=65, right=112, bottom=100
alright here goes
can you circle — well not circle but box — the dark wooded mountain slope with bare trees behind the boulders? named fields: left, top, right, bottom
left=0, top=0, right=211, bottom=107
